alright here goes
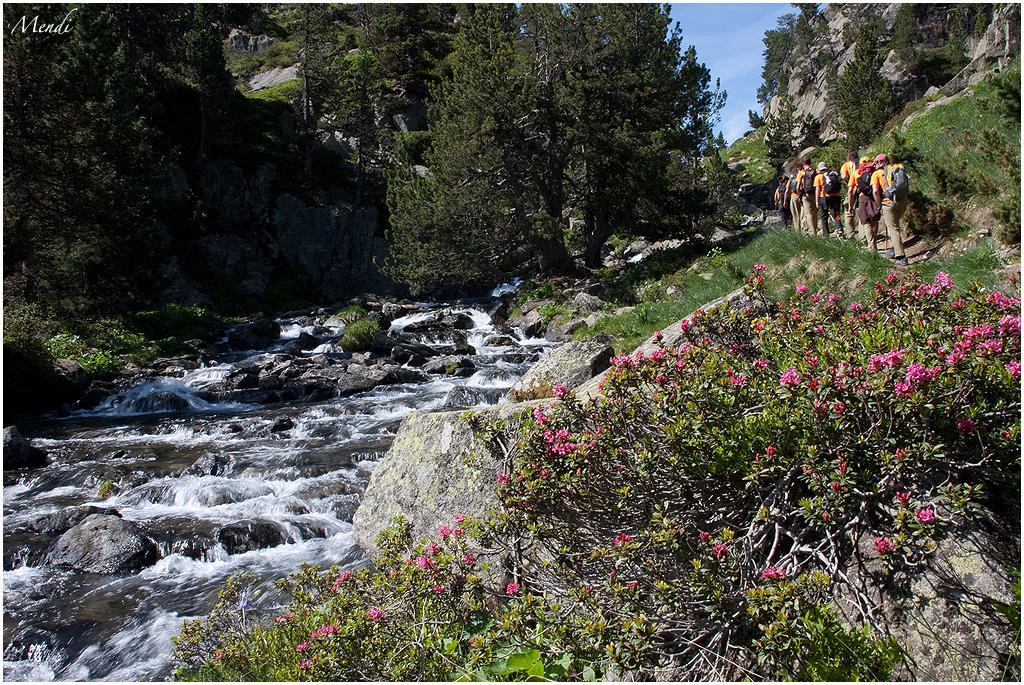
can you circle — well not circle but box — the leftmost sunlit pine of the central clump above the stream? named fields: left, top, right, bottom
left=385, top=5, right=531, bottom=293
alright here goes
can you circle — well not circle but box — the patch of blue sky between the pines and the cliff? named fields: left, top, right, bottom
left=672, top=3, right=796, bottom=143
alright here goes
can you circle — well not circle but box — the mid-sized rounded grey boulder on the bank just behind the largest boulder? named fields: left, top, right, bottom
left=509, top=340, right=615, bottom=401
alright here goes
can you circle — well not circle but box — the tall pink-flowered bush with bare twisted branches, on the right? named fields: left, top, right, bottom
left=475, top=270, right=1020, bottom=680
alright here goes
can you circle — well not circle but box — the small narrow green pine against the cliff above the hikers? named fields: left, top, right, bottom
left=836, top=23, right=894, bottom=147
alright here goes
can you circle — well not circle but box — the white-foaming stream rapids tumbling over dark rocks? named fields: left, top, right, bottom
left=3, top=288, right=551, bottom=681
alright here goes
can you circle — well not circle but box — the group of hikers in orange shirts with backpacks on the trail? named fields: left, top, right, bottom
left=775, top=149, right=909, bottom=266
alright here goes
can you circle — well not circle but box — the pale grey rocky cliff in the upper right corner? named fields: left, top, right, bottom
left=765, top=3, right=1021, bottom=141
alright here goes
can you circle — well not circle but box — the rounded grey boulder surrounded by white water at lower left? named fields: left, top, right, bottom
left=46, top=514, right=159, bottom=573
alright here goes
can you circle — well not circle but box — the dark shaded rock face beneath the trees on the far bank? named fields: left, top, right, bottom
left=155, top=160, right=400, bottom=305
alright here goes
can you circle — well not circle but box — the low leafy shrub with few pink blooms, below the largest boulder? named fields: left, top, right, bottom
left=174, top=516, right=608, bottom=681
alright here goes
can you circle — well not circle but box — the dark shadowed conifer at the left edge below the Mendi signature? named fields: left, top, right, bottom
left=3, top=5, right=155, bottom=316
